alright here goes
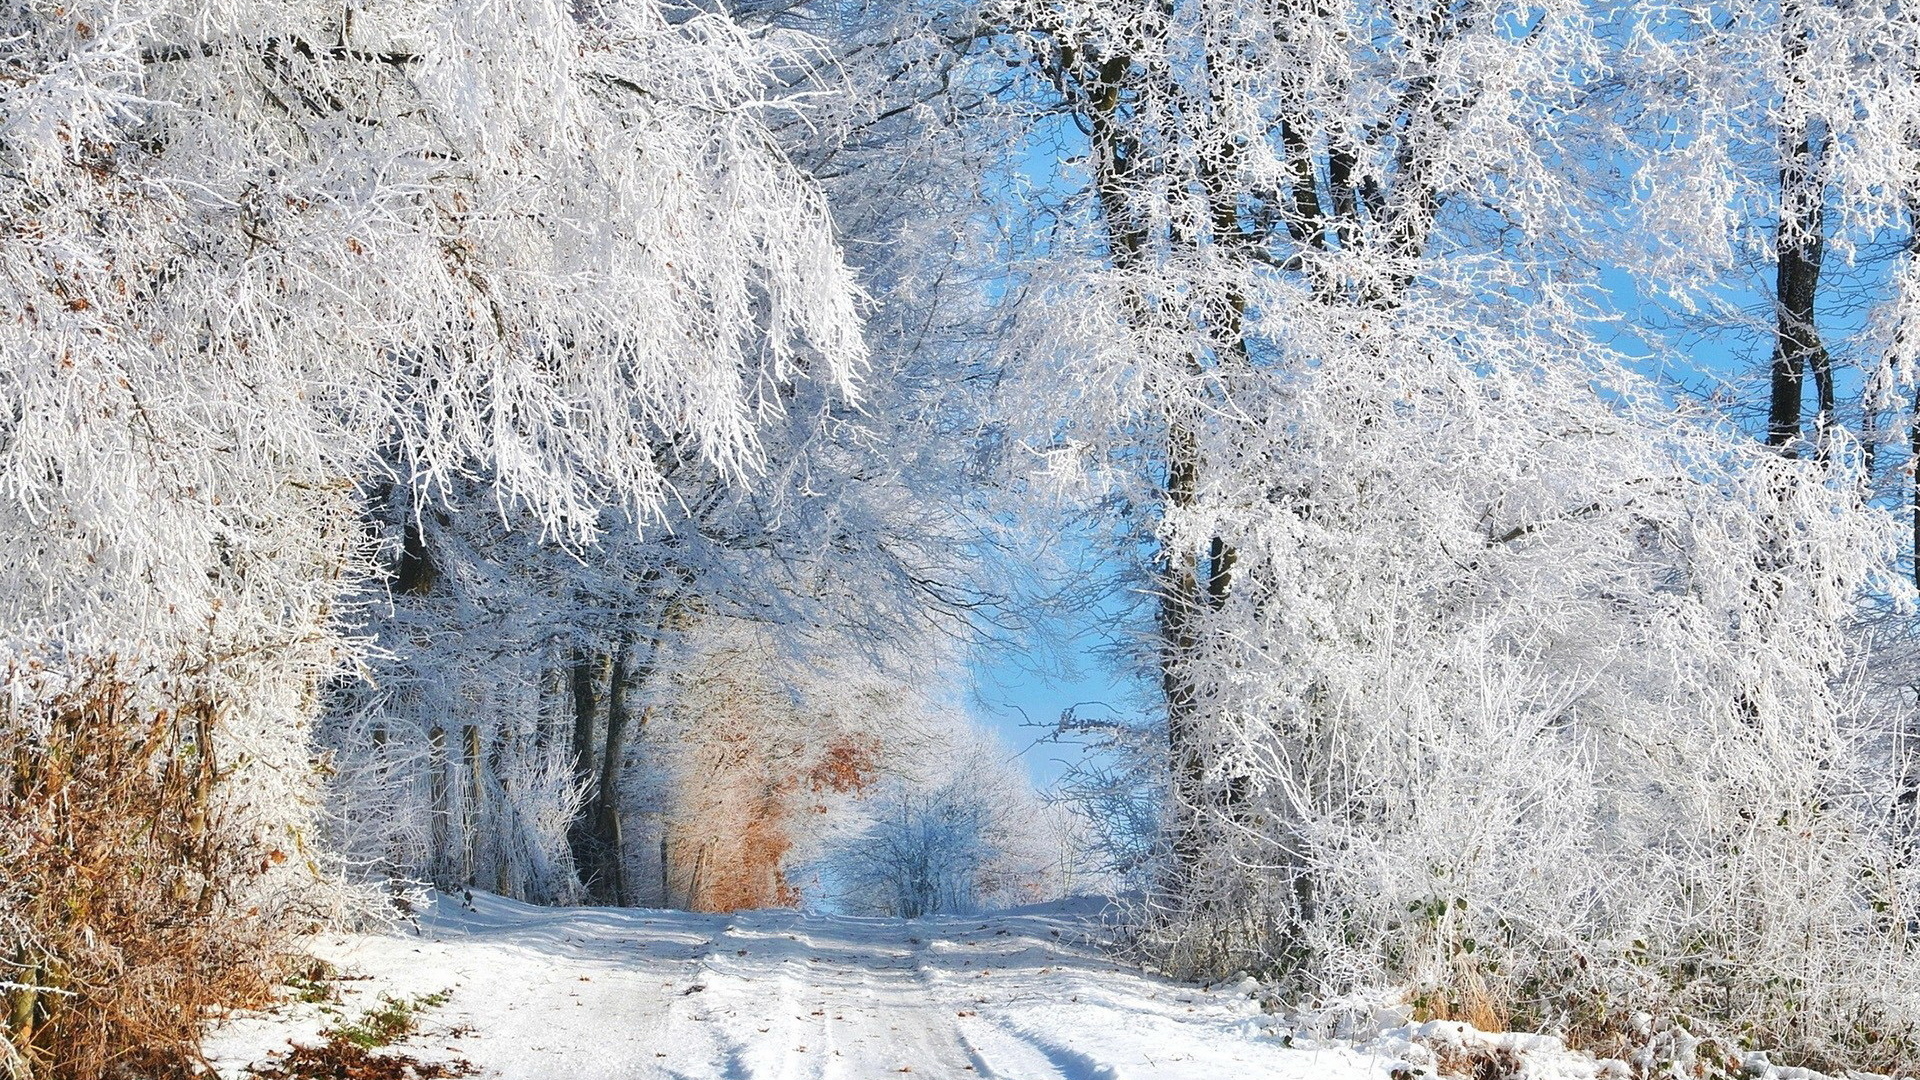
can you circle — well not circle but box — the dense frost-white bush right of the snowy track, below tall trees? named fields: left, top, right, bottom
left=1154, top=292, right=1920, bottom=1063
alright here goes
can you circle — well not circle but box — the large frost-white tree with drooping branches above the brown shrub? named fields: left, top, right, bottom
left=0, top=0, right=866, bottom=1053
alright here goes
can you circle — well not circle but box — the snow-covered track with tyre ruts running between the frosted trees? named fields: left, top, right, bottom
left=205, top=894, right=1607, bottom=1080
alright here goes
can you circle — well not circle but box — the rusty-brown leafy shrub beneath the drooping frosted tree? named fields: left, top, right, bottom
left=0, top=665, right=286, bottom=1080
